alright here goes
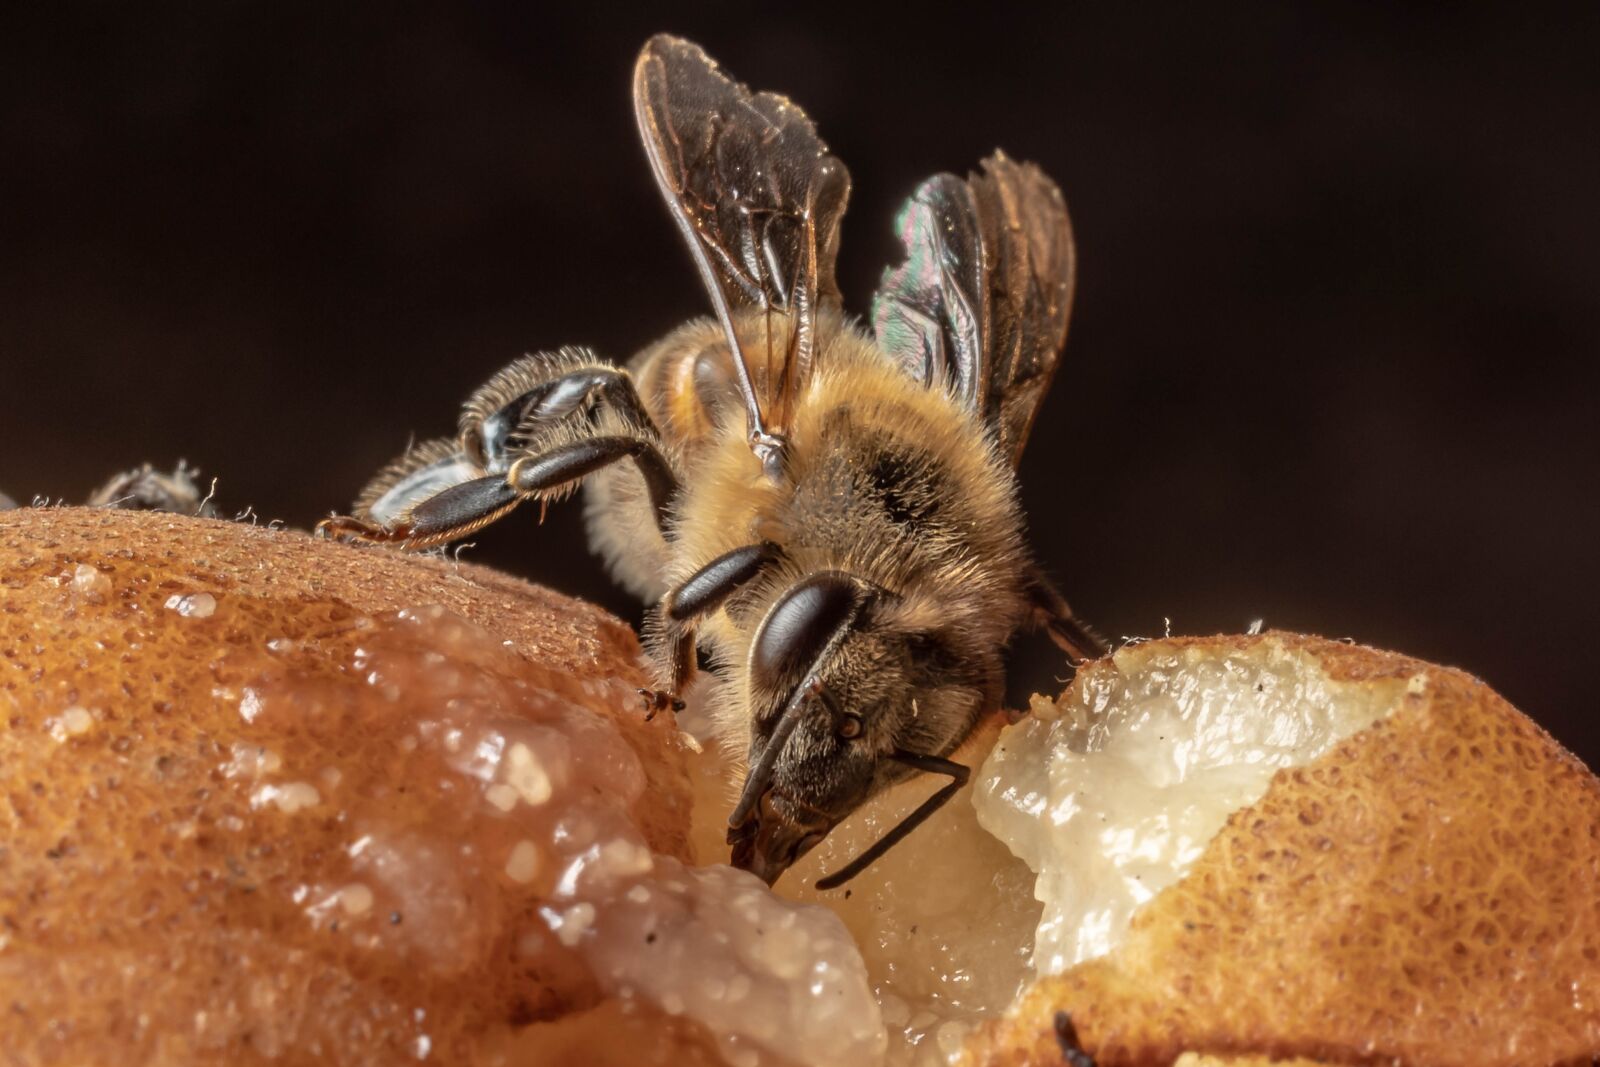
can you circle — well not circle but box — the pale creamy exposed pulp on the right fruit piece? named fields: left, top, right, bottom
left=976, top=640, right=1394, bottom=974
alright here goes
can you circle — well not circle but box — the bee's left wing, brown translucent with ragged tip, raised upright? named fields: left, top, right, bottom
left=634, top=35, right=850, bottom=434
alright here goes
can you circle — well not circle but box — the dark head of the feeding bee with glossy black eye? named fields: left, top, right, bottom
left=728, top=571, right=992, bottom=888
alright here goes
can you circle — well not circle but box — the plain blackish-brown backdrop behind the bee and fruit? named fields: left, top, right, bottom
left=0, top=3, right=1600, bottom=765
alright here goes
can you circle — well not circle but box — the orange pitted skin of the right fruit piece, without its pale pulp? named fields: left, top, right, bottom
left=971, top=633, right=1600, bottom=1067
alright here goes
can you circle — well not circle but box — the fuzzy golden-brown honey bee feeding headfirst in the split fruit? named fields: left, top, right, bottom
left=320, top=35, right=1104, bottom=888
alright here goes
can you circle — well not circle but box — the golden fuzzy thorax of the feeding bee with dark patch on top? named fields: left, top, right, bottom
left=589, top=320, right=1027, bottom=758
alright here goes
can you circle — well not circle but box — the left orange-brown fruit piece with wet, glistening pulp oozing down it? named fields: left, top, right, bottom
left=0, top=510, right=885, bottom=1067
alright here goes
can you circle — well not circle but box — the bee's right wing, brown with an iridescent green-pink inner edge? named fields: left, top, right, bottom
left=872, top=152, right=1075, bottom=464
